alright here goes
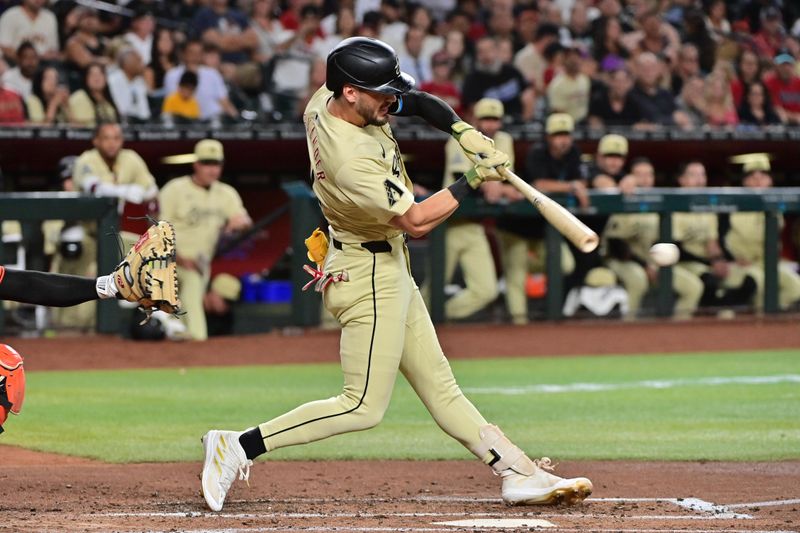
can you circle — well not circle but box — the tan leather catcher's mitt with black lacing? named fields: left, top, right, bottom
left=112, top=220, right=181, bottom=318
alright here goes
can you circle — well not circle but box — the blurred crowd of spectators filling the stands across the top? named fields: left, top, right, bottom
left=0, top=0, right=800, bottom=129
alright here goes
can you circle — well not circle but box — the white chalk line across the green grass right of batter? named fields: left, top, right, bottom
left=462, top=374, right=800, bottom=396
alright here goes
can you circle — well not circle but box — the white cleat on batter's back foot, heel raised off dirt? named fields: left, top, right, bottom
left=201, top=430, right=253, bottom=511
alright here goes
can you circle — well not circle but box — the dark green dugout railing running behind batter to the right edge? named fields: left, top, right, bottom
left=284, top=181, right=800, bottom=326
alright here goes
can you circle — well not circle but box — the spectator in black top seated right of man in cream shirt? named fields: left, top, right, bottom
left=589, top=66, right=641, bottom=128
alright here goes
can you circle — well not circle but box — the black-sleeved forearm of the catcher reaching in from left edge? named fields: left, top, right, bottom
left=0, top=269, right=100, bottom=307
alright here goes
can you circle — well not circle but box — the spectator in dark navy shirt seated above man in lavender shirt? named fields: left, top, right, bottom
left=192, top=0, right=259, bottom=68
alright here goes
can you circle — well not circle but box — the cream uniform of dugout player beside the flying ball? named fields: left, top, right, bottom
left=603, top=213, right=703, bottom=318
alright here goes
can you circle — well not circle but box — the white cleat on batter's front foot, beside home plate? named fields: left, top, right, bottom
left=500, top=457, right=592, bottom=505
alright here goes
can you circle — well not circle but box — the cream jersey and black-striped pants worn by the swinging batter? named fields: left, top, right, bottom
left=259, top=87, right=486, bottom=458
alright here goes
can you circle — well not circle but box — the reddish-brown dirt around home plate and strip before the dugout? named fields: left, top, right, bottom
left=0, top=321, right=800, bottom=533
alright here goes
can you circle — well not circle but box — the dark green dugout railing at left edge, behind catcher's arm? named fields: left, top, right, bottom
left=0, top=192, right=120, bottom=335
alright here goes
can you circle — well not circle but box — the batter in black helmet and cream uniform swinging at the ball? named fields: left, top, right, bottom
left=202, top=37, right=592, bottom=511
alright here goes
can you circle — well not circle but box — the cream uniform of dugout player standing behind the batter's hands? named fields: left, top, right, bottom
left=443, top=131, right=514, bottom=319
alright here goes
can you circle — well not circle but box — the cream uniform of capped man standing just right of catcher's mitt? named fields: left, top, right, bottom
left=159, top=176, right=246, bottom=340
